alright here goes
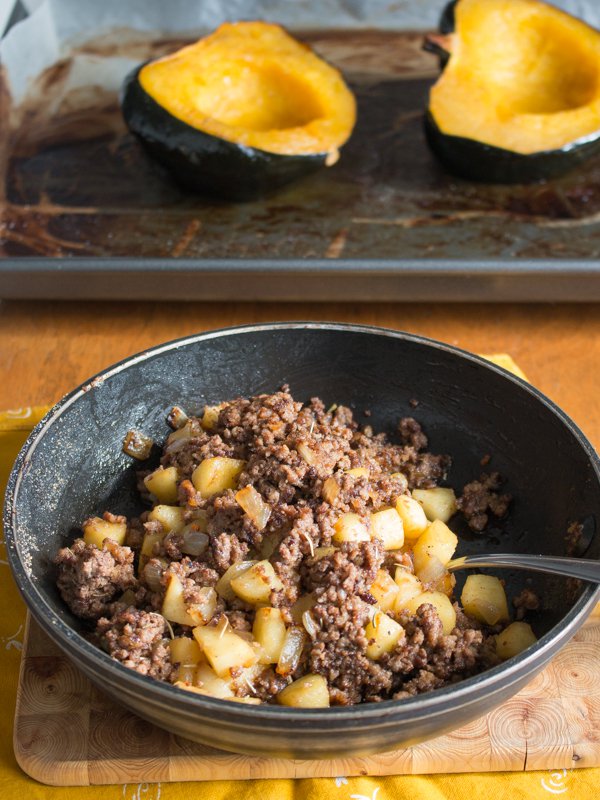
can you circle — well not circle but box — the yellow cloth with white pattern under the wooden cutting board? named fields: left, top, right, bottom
left=0, top=364, right=600, bottom=800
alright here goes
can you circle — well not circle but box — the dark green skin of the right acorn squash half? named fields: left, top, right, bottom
left=425, top=0, right=600, bottom=184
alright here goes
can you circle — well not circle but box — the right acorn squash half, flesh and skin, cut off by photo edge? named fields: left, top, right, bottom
left=425, top=0, right=600, bottom=183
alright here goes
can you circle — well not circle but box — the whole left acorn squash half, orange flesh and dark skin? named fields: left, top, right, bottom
left=121, top=22, right=356, bottom=200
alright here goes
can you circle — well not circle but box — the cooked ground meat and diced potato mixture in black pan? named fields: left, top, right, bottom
left=55, top=387, right=535, bottom=707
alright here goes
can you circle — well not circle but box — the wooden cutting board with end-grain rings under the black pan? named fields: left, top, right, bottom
left=14, top=606, right=600, bottom=786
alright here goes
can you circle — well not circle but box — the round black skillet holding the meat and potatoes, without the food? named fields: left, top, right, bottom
left=5, top=323, right=600, bottom=758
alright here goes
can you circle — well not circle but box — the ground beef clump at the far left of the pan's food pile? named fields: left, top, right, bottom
left=54, top=539, right=136, bottom=619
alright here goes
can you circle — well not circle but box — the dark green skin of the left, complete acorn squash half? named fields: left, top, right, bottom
left=121, top=64, right=327, bottom=200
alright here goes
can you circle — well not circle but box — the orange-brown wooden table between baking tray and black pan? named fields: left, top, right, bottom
left=0, top=300, right=600, bottom=448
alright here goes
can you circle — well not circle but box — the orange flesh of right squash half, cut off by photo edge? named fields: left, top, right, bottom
left=429, top=0, right=600, bottom=154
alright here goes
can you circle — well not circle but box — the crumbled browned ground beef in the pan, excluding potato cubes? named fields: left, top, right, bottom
left=56, top=387, right=510, bottom=705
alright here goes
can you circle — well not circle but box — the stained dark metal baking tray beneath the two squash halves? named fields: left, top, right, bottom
left=0, top=2, right=600, bottom=301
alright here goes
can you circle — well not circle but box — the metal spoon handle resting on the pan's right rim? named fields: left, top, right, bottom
left=446, top=553, right=600, bottom=583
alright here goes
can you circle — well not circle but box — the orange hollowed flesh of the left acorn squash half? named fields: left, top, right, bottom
left=139, top=22, right=356, bottom=155
